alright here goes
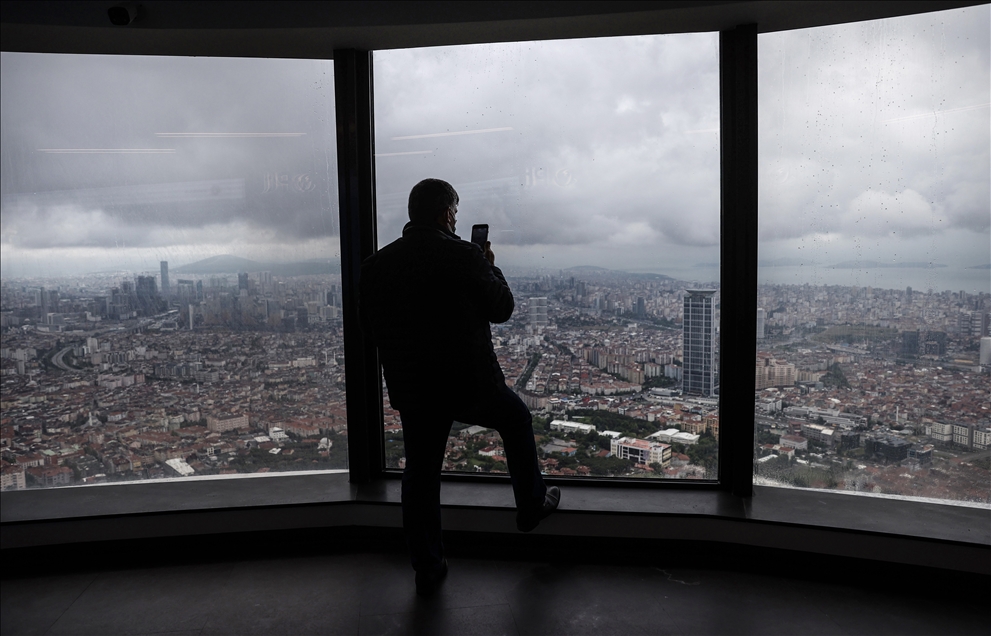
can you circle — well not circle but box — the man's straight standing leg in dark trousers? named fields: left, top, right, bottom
left=400, top=409, right=453, bottom=572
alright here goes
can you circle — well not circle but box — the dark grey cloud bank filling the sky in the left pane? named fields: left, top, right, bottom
left=2, top=53, right=337, bottom=248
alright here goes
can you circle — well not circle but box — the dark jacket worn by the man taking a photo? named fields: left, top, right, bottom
left=358, top=223, right=514, bottom=410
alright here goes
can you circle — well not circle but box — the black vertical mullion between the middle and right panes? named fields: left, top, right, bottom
left=719, top=24, right=757, bottom=497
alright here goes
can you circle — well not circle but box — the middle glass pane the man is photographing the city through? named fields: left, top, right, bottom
left=375, top=34, right=719, bottom=479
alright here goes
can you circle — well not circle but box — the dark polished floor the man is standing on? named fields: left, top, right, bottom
left=0, top=540, right=989, bottom=636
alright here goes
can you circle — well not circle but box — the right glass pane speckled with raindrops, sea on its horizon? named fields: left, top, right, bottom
left=755, top=5, right=991, bottom=505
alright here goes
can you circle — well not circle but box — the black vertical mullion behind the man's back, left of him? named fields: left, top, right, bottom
left=334, top=49, right=384, bottom=483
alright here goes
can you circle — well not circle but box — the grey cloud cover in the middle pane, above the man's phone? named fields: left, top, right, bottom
left=375, top=34, right=719, bottom=249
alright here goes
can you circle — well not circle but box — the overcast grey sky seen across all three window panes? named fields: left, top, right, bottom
left=0, top=5, right=991, bottom=286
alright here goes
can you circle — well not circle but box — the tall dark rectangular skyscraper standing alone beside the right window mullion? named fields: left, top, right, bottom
left=682, top=289, right=716, bottom=396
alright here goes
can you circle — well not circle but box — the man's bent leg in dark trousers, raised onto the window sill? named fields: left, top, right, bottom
left=457, top=385, right=547, bottom=510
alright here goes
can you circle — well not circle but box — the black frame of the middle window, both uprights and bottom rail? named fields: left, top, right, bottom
left=334, top=24, right=757, bottom=497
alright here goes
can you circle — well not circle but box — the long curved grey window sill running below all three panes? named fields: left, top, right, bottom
left=0, top=472, right=991, bottom=574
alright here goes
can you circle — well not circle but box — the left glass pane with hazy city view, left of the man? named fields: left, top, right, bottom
left=0, top=53, right=347, bottom=489
